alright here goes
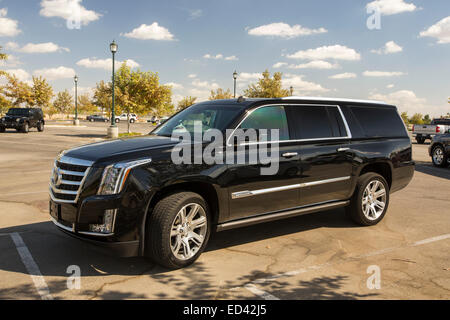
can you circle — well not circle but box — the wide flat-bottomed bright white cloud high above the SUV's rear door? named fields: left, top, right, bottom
left=287, top=44, right=361, bottom=61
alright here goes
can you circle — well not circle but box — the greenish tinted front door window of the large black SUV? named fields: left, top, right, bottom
left=240, top=106, right=289, bottom=141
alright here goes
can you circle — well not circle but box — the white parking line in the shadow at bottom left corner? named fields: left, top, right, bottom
left=10, top=232, right=53, bottom=300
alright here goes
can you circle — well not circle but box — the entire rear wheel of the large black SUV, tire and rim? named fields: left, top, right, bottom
left=346, top=172, right=389, bottom=226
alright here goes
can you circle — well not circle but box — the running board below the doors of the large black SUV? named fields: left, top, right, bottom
left=217, top=200, right=350, bottom=231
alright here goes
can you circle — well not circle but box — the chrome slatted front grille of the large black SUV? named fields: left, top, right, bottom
left=50, top=156, right=93, bottom=203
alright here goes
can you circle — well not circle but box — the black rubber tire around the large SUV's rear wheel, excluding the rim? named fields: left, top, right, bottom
left=346, top=172, right=389, bottom=226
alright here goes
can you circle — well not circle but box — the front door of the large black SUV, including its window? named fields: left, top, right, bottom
left=226, top=106, right=299, bottom=220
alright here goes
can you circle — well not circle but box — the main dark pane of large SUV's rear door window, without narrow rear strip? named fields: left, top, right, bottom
left=290, top=106, right=339, bottom=139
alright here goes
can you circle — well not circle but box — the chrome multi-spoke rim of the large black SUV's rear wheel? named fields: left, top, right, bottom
left=362, top=180, right=386, bottom=221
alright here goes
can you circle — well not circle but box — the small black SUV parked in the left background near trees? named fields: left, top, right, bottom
left=0, top=108, right=45, bottom=133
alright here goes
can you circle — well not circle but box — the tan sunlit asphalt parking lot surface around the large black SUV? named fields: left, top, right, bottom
left=0, top=122, right=450, bottom=299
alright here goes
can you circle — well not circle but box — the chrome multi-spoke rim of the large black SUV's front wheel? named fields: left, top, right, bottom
left=170, top=203, right=208, bottom=260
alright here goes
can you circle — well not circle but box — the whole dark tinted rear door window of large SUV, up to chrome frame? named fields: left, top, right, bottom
left=289, top=106, right=347, bottom=140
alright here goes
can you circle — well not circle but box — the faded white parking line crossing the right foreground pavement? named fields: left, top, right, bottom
left=239, top=233, right=450, bottom=300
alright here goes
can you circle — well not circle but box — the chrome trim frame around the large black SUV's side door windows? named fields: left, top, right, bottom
left=226, top=103, right=353, bottom=147
